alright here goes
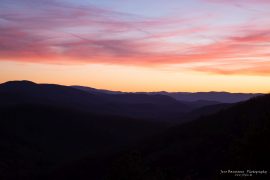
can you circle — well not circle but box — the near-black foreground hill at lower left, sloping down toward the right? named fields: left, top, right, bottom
left=0, top=104, right=166, bottom=180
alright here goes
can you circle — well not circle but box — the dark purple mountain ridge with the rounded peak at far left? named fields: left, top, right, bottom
left=0, top=81, right=194, bottom=121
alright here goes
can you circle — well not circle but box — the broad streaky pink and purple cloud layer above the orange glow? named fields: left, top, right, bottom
left=0, top=0, right=270, bottom=74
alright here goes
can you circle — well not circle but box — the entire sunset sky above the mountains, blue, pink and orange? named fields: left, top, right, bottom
left=0, top=0, right=270, bottom=93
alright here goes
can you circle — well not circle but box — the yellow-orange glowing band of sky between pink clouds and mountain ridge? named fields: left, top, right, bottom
left=0, top=62, right=270, bottom=93
